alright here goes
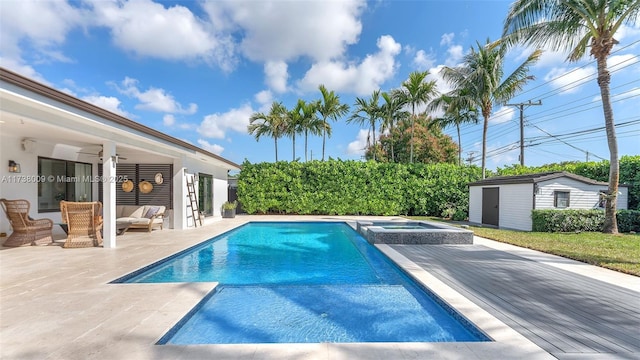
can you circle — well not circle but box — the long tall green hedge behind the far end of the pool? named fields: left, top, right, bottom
left=238, top=160, right=482, bottom=218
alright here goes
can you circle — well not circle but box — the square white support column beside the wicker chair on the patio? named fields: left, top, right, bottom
left=100, top=141, right=117, bottom=248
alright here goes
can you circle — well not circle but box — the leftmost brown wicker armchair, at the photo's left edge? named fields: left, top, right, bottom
left=0, top=199, right=53, bottom=246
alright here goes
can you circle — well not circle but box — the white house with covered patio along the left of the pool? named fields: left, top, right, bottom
left=0, top=68, right=240, bottom=248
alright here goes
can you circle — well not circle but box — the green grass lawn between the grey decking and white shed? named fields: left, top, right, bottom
left=411, top=217, right=640, bottom=276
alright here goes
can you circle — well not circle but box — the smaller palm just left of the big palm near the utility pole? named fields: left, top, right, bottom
left=429, top=89, right=478, bottom=165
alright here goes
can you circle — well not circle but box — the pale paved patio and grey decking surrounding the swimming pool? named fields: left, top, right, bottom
left=0, top=215, right=640, bottom=359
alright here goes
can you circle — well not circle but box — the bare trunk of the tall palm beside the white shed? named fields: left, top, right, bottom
left=596, top=55, right=620, bottom=234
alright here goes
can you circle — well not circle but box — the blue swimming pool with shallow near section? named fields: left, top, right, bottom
left=115, top=222, right=489, bottom=344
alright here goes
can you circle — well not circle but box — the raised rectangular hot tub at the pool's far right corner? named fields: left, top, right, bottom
left=356, top=221, right=473, bottom=245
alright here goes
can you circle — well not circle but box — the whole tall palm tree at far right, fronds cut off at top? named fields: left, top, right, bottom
left=503, top=0, right=640, bottom=234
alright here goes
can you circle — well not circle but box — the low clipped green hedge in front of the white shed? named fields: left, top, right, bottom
left=531, top=210, right=640, bottom=232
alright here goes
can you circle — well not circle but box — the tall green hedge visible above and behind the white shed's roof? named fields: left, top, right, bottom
left=497, top=155, right=640, bottom=210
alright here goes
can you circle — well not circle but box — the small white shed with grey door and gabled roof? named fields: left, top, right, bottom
left=469, top=172, right=629, bottom=231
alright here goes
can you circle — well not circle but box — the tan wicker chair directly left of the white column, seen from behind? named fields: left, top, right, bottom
left=60, top=200, right=103, bottom=248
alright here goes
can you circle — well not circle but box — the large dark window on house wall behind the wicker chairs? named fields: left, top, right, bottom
left=38, top=157, right=92, bottom=212
